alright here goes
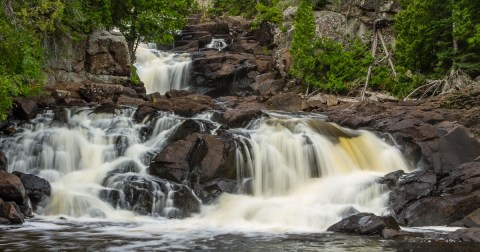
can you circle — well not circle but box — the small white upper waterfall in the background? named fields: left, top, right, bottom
left=135, top=47, right=192, bottom=94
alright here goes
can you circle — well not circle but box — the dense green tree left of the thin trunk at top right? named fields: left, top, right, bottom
left=395, top=0, right=454, bottom=73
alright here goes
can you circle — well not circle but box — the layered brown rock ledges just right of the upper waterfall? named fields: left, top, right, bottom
left=172, top=17, right=282, bottom=97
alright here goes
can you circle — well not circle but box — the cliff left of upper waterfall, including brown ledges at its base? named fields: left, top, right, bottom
left=40, top=30, right=145, bottom=105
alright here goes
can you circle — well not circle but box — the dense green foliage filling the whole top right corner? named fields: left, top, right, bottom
left=395, top=0, right=480, bottom=77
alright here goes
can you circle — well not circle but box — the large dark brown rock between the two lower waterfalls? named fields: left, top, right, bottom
left=148, top=120, right=236, bottom=202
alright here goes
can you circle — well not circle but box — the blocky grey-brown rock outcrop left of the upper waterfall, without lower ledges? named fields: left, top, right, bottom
left=46, top=30, right=131, bottom=87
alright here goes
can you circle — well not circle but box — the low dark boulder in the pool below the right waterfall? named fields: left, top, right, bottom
left=327, top=213, right=400, bottom=235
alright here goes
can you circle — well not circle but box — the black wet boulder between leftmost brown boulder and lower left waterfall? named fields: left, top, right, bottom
left=13, top=171, right=52, bottom=207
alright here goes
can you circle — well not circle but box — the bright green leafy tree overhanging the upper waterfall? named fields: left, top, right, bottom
left=110, top=0, right=195, bottom=55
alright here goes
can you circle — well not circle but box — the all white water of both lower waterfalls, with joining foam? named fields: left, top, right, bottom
left=1, top=109, right=407, bottom=233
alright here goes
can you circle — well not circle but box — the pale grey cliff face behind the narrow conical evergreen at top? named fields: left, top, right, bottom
left=274, top=0, right=400, bottom=77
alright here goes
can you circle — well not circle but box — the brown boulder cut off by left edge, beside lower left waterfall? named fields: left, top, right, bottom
left=0, top=171, right=26, bottom=205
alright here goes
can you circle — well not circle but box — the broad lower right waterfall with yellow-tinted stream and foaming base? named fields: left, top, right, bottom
left=199, top=114, right=408, bottom=232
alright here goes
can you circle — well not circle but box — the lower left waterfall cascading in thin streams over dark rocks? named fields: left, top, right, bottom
left=1, top=108, right=191, bottom=220
